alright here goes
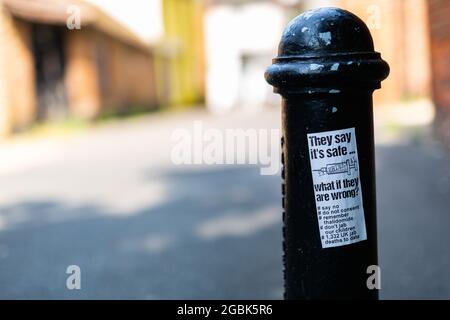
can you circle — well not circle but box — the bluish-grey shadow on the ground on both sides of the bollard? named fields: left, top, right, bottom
left=0, top=139, right=450, bottom=299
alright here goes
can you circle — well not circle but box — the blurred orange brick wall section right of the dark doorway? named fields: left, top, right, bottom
left=65, top=28, right=158, bottom=119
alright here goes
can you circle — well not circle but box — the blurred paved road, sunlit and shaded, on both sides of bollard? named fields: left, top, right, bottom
left=0, top=110, right=450, bottom=299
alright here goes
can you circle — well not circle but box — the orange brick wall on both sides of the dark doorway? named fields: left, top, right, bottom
left=0, top=2, right=158, bottom=137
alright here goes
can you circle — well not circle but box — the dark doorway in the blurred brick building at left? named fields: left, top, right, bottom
left=33, top=24, right=68, bottom=121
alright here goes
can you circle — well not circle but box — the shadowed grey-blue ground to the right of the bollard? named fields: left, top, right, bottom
left=377, top=141, right=450, bottom=299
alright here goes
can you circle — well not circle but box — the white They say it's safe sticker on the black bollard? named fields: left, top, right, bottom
left=308, top=128, right=367, bottom=248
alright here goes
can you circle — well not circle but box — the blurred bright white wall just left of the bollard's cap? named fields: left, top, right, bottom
left=205, top=2, right=286, bottom=113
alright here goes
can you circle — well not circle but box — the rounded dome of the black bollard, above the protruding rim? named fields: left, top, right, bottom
left=278, top=8, right=374, bottom=57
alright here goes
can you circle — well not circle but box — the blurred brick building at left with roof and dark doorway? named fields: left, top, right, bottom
left=0, top=0, right=157, bottom=136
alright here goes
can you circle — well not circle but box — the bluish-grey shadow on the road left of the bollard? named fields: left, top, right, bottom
left=0, top=167, right=282, bottom=299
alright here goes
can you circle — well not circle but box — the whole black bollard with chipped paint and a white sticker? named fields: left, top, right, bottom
left=265, top=8, right=389, bottom=299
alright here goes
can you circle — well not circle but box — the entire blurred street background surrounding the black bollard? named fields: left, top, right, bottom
left=0, top=0, right=450, bottom=299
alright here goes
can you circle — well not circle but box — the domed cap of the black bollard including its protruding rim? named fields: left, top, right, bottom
left=265, top=8, right=389, bottom=95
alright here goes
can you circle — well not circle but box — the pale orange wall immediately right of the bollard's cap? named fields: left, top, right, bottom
left=338, top=0, right=430, bottom=103
